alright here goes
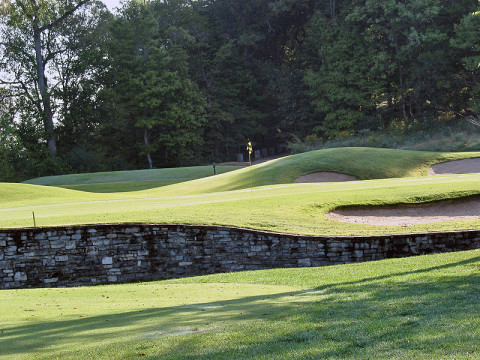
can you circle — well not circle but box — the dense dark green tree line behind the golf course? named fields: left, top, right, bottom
left=0, top=0, right=480, bottom=181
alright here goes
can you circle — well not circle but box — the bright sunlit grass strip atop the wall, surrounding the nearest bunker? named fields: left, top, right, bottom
left=4, top=174, right=480, bottom=235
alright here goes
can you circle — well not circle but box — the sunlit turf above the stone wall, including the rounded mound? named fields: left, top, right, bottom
left=4, top=148, right=480, bottom=235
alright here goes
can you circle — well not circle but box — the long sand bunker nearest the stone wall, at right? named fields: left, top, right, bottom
left=326, top=198, right=480, bottom=226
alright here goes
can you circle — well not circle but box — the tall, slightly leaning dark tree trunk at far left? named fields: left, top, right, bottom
left=33, top=29, right=57, bottom=157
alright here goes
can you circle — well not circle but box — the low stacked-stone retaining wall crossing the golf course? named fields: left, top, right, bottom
left=0, top=224, right=480, bottom=289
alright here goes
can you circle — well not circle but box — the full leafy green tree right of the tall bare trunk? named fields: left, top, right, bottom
left=105, top=2, right=204, bottom=166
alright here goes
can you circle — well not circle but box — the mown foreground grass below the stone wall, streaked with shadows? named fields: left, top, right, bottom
left=0, top=250, right=480, bottom=360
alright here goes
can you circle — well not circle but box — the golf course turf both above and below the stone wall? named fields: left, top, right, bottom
left=0, top=148, right=480, bottom=360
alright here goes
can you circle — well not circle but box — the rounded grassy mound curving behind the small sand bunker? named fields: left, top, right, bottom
left=123, top=148, right=480, bottom=195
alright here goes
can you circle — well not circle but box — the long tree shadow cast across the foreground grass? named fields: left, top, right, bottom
left=0, top=257, right=480, bottom=360
